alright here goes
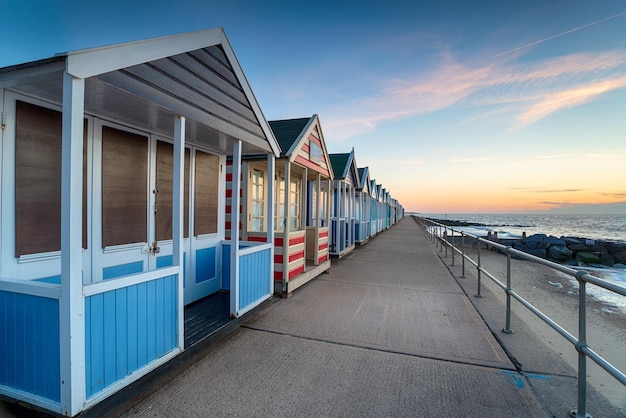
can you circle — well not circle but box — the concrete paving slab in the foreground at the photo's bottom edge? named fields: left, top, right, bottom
left=123, top=329, right=548, bottom=417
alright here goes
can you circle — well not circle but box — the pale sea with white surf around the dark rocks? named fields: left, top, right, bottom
left=418, top=213, right=626, bottom=313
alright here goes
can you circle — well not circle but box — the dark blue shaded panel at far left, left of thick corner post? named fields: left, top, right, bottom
left=0, top=291, right=61, bottom=402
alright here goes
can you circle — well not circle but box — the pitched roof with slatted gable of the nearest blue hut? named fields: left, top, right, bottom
left=0, top=28, right=279, bottom=155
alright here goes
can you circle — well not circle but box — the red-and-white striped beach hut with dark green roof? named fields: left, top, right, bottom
left=227, top=115, right=333, bottom=297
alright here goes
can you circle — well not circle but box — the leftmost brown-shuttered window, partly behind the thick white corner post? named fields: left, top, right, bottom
left=15, top=100, right=87, bottom=257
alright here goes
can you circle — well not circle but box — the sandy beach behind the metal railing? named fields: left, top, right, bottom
left=440, top=240, right=626, bottom=415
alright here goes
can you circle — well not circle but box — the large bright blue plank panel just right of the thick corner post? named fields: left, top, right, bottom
left=84, top=276, right=177, bottom=398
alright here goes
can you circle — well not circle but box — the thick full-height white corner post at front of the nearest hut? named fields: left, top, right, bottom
left=59, top=73, right=85, bottom=416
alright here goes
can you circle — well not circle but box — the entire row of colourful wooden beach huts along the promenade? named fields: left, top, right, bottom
left=0, top=29, right=404, bottom=416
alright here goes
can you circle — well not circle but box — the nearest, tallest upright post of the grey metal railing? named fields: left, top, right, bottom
left=570, top=270, right=590, bottom=418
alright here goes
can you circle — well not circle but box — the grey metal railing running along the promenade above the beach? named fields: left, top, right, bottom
left=415, top=217, right=626, bottom=417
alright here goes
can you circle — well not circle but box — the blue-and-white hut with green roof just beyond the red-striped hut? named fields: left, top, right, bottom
left=329, top=149, right=359, bottom=257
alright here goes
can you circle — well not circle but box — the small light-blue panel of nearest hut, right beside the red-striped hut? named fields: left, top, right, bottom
left=239, top=248, right=273, bottom=310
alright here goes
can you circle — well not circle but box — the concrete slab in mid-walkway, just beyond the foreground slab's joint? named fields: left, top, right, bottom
left=246, top=274, right=514, bottom=369
